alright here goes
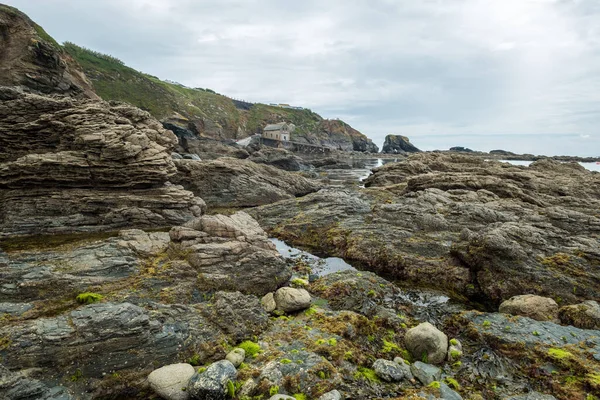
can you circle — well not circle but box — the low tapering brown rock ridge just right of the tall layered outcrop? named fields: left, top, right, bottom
left=174, top=158, right=319, bottom=207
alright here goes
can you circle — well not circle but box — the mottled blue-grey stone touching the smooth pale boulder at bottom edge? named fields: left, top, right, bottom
left=187, top=360, right=237, bottom=400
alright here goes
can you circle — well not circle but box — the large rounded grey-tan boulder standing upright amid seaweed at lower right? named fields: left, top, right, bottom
left=404, top=322, right=448, bottom=366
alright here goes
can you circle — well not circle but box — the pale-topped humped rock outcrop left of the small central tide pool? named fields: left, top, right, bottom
left=170, top=211, right=291, bottom=294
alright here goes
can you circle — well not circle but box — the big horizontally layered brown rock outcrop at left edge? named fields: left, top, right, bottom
left=0, top=88, right=204, bottom=236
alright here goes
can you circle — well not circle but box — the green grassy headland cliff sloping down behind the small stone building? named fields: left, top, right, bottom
left=64, top=43, right=378, bottom=152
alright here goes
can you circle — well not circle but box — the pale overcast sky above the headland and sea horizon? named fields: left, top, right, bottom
left=8, top=0, right=600, bottom=156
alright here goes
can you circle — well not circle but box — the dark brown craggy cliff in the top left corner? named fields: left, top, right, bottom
left=0, top=5, right=99, bottom=99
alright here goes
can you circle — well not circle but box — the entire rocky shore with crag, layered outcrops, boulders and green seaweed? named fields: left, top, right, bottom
left=0, top=5, right=600, bottom=400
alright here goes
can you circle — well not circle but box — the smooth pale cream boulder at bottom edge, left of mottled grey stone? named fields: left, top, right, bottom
left=148, top=364, right=196, bottom=400
